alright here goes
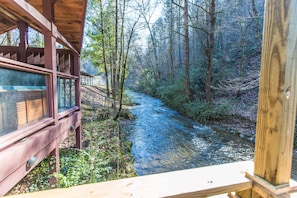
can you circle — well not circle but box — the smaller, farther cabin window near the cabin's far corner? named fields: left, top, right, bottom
left=58, top=77, right=75, bottom=112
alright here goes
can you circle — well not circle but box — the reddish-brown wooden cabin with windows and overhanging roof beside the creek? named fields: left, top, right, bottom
left=0, top=0, right=86, bottom=196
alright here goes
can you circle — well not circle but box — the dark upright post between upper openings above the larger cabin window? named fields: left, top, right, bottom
left=18, top=21, right=28, bottom=63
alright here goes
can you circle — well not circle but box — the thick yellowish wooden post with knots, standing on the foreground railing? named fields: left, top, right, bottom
left=250, top=0, right=297, bottom=197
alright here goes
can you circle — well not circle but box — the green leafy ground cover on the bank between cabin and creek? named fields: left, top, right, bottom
left=11, top=104, right=135, bottom=194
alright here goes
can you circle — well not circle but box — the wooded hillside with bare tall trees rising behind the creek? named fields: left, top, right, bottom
left=82, top=0, right=294, bottom=148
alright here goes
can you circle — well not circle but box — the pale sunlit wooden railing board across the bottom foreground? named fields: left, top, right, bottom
left=6, top=161, right=253, bottom=198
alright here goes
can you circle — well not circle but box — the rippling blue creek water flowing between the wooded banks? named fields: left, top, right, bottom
left=126, top=92, right=254, bottom=175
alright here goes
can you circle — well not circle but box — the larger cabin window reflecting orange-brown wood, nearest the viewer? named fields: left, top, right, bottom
left=0, top=67, right=49, bottom=136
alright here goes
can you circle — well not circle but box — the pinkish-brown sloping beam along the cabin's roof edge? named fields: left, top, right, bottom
left=0, top=0, right=80, bottom=53
